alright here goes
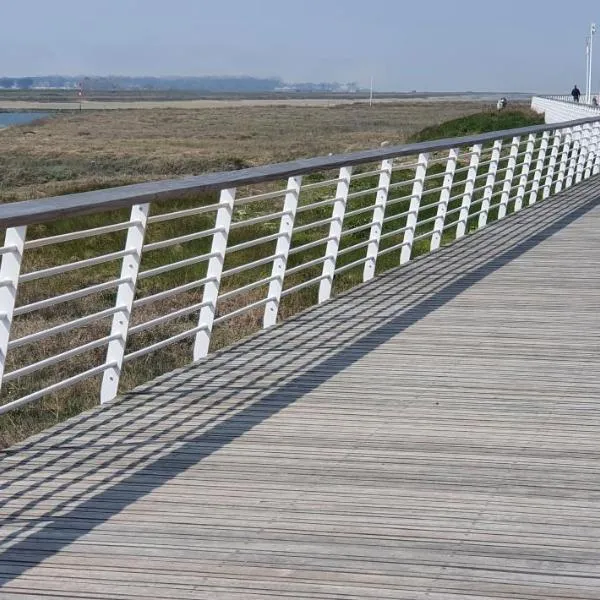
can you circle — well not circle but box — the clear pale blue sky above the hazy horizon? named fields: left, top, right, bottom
left=0, top=0, right=600, bottom=93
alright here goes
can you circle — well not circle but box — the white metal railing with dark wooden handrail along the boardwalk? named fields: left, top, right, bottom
left=0, top=115, right=600, bottom=414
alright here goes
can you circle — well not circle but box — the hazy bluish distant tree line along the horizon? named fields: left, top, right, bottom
left=0, top=76, right=360, bottom=93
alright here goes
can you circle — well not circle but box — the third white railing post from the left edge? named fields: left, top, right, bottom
left=193, top=188, right=236, bottom=361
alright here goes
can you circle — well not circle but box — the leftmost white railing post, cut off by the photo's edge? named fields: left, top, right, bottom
left=0, top=226, right=27, bottom=386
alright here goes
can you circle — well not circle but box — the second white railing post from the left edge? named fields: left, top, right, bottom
left=100, top=204, right=150, bottom=404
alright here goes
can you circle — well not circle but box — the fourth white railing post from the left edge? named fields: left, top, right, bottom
left=263, top=176, right=302, bottom=328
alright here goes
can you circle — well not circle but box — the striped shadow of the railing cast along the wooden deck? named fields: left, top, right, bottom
left=0, top=178, right=600, bottom=587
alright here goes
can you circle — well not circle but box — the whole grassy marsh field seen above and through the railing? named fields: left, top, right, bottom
left=0, top=102, right=539, bottom=447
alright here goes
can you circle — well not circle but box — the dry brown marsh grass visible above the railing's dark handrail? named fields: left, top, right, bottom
left=0, top=101, right=484, bottom=201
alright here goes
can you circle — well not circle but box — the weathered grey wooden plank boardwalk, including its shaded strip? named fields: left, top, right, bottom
left=0, top=178, right=600, bottom=600
